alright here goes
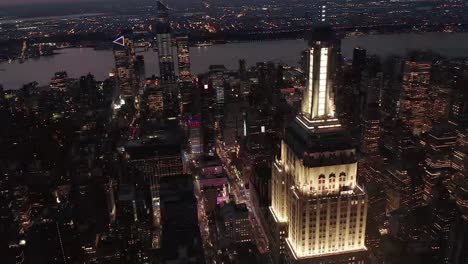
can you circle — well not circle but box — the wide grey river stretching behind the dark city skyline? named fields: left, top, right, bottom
left=0, top=33, right=468, bottom=89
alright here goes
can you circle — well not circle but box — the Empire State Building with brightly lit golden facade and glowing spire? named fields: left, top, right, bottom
left=270, top=27, right=368, bottom=264
